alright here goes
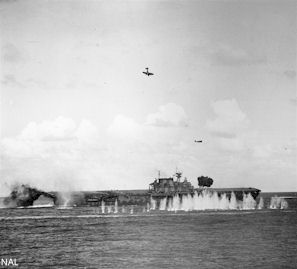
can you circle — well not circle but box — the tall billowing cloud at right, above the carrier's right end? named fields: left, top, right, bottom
left=204, top=99, right=297, bottom=191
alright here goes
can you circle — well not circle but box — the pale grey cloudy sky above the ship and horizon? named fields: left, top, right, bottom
left=0, top=0, right=297, bottom=195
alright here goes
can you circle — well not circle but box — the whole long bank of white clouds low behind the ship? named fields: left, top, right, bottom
left=0, top=99, right=296, bottom=195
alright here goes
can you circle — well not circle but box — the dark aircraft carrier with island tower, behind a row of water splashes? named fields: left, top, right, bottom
left=52, top=172, right=261, bottom=207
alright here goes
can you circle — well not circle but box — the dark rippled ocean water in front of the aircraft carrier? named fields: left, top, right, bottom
left=0, top=193, right=297, bottom=269
